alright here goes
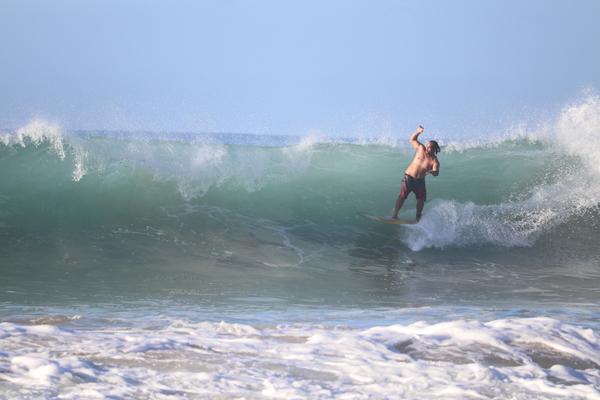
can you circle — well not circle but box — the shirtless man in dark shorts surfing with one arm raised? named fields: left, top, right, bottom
left=392, top=125, right=440, bottom=222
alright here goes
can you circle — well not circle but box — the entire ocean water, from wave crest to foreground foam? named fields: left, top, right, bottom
left=0, top=96, right=600, bottom=399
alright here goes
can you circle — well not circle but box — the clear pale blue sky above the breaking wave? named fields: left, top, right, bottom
left=0, top=0, right=600, bottom=136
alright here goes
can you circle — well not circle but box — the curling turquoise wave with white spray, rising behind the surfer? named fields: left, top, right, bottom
left=0, top=96, right=600, bottom=250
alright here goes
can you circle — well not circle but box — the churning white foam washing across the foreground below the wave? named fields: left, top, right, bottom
left=0, top=318, right=600, bottom=399
